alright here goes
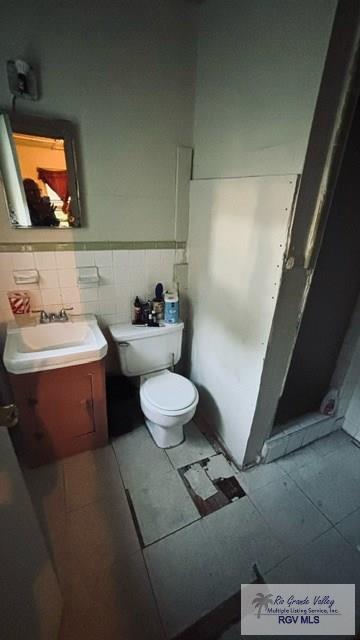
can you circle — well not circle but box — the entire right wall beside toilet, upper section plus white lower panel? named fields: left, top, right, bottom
left=188, top=0, right=336, bottom=464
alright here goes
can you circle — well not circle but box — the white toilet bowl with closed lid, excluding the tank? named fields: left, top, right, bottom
left=140, top=369, right=199, bottom=449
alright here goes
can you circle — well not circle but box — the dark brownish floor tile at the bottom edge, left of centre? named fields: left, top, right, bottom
left=59, top=552, right=164, bottom=640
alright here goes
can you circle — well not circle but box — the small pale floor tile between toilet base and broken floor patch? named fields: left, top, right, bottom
left=166, top=422, right=216, bottom=469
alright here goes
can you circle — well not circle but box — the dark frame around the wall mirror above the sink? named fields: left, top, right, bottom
left=1, top=111, right=81, bottom=231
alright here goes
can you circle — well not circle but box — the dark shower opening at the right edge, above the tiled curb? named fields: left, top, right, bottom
left=274, top=97, right=360, bottom=426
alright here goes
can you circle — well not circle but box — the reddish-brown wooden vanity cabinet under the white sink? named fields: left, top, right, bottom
left=10, top=360, right=108, bottom=467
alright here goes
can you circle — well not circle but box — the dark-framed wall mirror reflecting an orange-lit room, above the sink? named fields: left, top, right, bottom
left=0, top=113, right=81, bottom=229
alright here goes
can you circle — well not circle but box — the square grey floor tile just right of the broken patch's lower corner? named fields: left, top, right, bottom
left=250, top=476, right=331, bottom=553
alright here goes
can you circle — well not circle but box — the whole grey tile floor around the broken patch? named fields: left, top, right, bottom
left=24, top=423, right=360, bottom=640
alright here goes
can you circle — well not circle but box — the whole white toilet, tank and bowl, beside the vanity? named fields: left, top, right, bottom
left=109, top=322, right=199, bottom=449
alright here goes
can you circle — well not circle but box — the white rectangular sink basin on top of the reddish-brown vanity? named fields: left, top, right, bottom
left=4, top=316, right=107, bottom=374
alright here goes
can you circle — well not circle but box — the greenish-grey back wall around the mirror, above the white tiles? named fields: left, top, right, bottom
left=0, top=0, right=196, bottom=242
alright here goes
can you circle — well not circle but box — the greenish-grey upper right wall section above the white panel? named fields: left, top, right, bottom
left=194, top=0, right=337, bottom=179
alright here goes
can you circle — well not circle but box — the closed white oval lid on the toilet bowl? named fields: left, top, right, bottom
left=142, top=373, right=196, bottom=411
